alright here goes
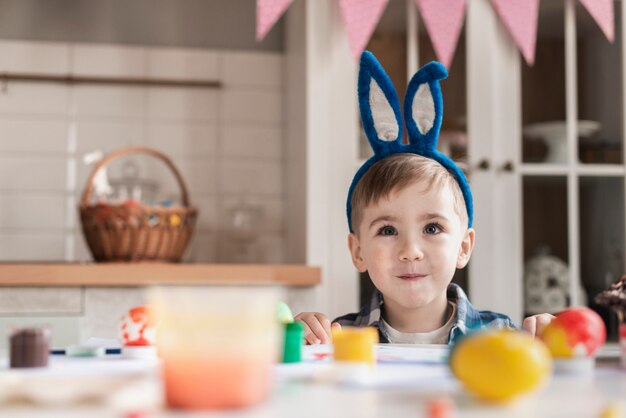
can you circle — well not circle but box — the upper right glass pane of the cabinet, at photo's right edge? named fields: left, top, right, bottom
left=576, top=1, right=623, bottom=164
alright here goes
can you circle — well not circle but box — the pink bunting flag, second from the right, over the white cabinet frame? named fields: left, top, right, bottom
left=491, top=0, right=540, bottom=65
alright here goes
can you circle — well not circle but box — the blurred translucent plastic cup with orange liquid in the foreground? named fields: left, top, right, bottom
left=149, top=287, right=280, bottom=409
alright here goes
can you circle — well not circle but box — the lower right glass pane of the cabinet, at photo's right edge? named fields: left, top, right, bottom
left=580, top=177, right=625, bottom=341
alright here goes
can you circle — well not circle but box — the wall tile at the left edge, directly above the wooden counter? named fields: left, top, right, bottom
left=0, top=230, right=65, bottom=261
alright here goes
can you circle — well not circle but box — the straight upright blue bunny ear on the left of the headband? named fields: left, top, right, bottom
left=358, top=51, right=402, bottom=154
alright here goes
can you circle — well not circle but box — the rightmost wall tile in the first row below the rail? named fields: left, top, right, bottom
left=220, top=88, right=282, bottom=125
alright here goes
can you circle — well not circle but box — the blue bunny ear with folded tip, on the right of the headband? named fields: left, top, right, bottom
left=404, top=61, right=448, bottom=154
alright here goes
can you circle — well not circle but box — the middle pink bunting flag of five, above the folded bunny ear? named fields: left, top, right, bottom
left=415, top=0, right=465, bottom=68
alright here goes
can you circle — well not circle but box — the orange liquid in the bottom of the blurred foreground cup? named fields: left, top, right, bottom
left=163, top=357, right=271, bottom=409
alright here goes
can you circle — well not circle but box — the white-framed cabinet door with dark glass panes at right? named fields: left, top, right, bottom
left=515, top=0, right=626, bottom=338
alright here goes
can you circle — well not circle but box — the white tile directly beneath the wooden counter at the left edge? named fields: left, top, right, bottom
left=0, top=287, right=83, bottom=314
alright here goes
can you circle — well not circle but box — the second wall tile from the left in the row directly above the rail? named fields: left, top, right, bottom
left=72, top=44, right=147, bottom=78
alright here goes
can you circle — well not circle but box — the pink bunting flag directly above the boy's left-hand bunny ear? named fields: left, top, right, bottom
left=339, top=0, right=389, bottom=59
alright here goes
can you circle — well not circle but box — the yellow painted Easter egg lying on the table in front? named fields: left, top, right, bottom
left=450, top=329, right=552, bottom=402
